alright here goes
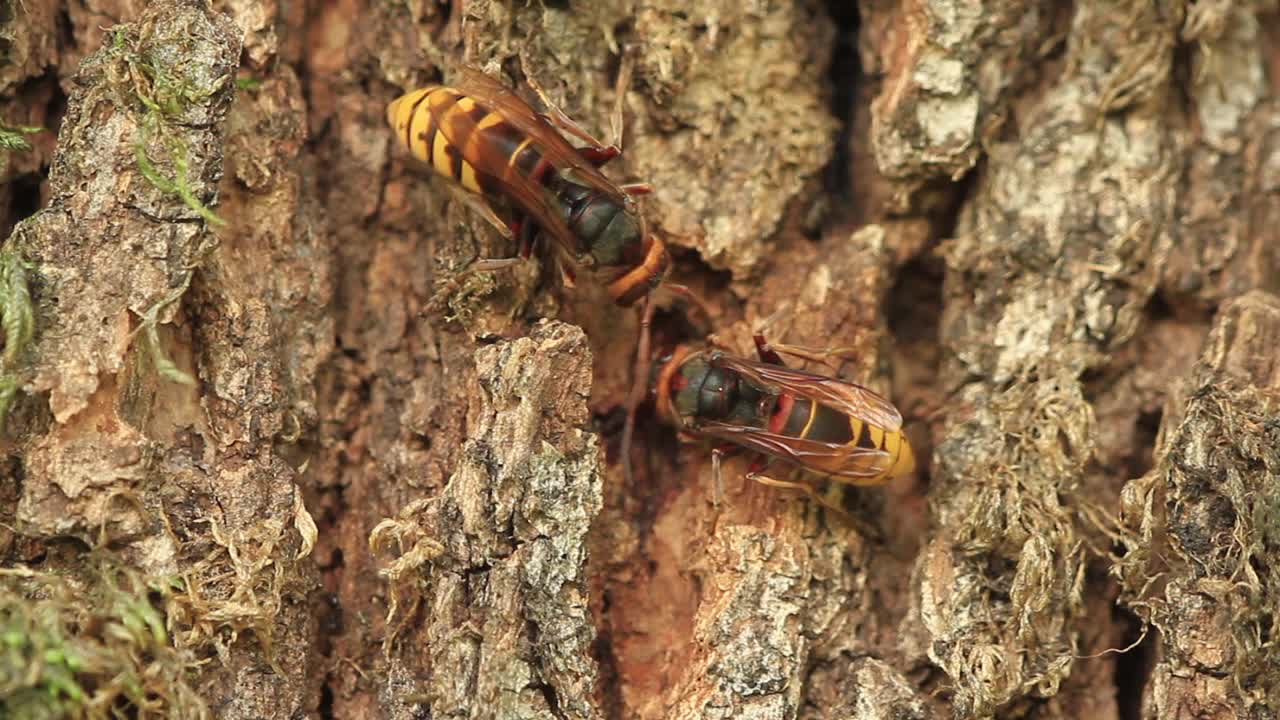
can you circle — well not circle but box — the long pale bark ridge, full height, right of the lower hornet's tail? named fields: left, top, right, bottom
left=916, top=3, right=1178, bottom=716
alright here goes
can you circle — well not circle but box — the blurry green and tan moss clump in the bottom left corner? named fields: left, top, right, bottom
left=0, top=559, right=210, bottom=720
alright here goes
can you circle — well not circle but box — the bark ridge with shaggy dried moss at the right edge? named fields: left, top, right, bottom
left=1115, top=292, right=1280, bottom=716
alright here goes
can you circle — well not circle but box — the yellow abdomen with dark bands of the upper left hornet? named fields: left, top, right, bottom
left=387, top=85, right=543, bottom=195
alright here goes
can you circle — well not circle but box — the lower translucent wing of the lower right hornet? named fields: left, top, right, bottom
left=696, top=423, right=893, bottom=484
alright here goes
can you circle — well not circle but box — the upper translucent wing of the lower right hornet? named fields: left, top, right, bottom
left=710, top=352, right=902, bottom=432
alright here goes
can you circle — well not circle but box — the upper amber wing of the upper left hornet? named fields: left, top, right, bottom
left=456, top=65, right=628, bottom=206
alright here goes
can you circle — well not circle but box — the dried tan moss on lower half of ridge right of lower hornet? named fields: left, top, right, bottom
left=918, top=380, right=1092, bottom=715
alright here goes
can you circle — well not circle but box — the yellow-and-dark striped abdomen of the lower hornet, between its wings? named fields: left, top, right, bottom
left=769, top=395, right=915, bottom=484
